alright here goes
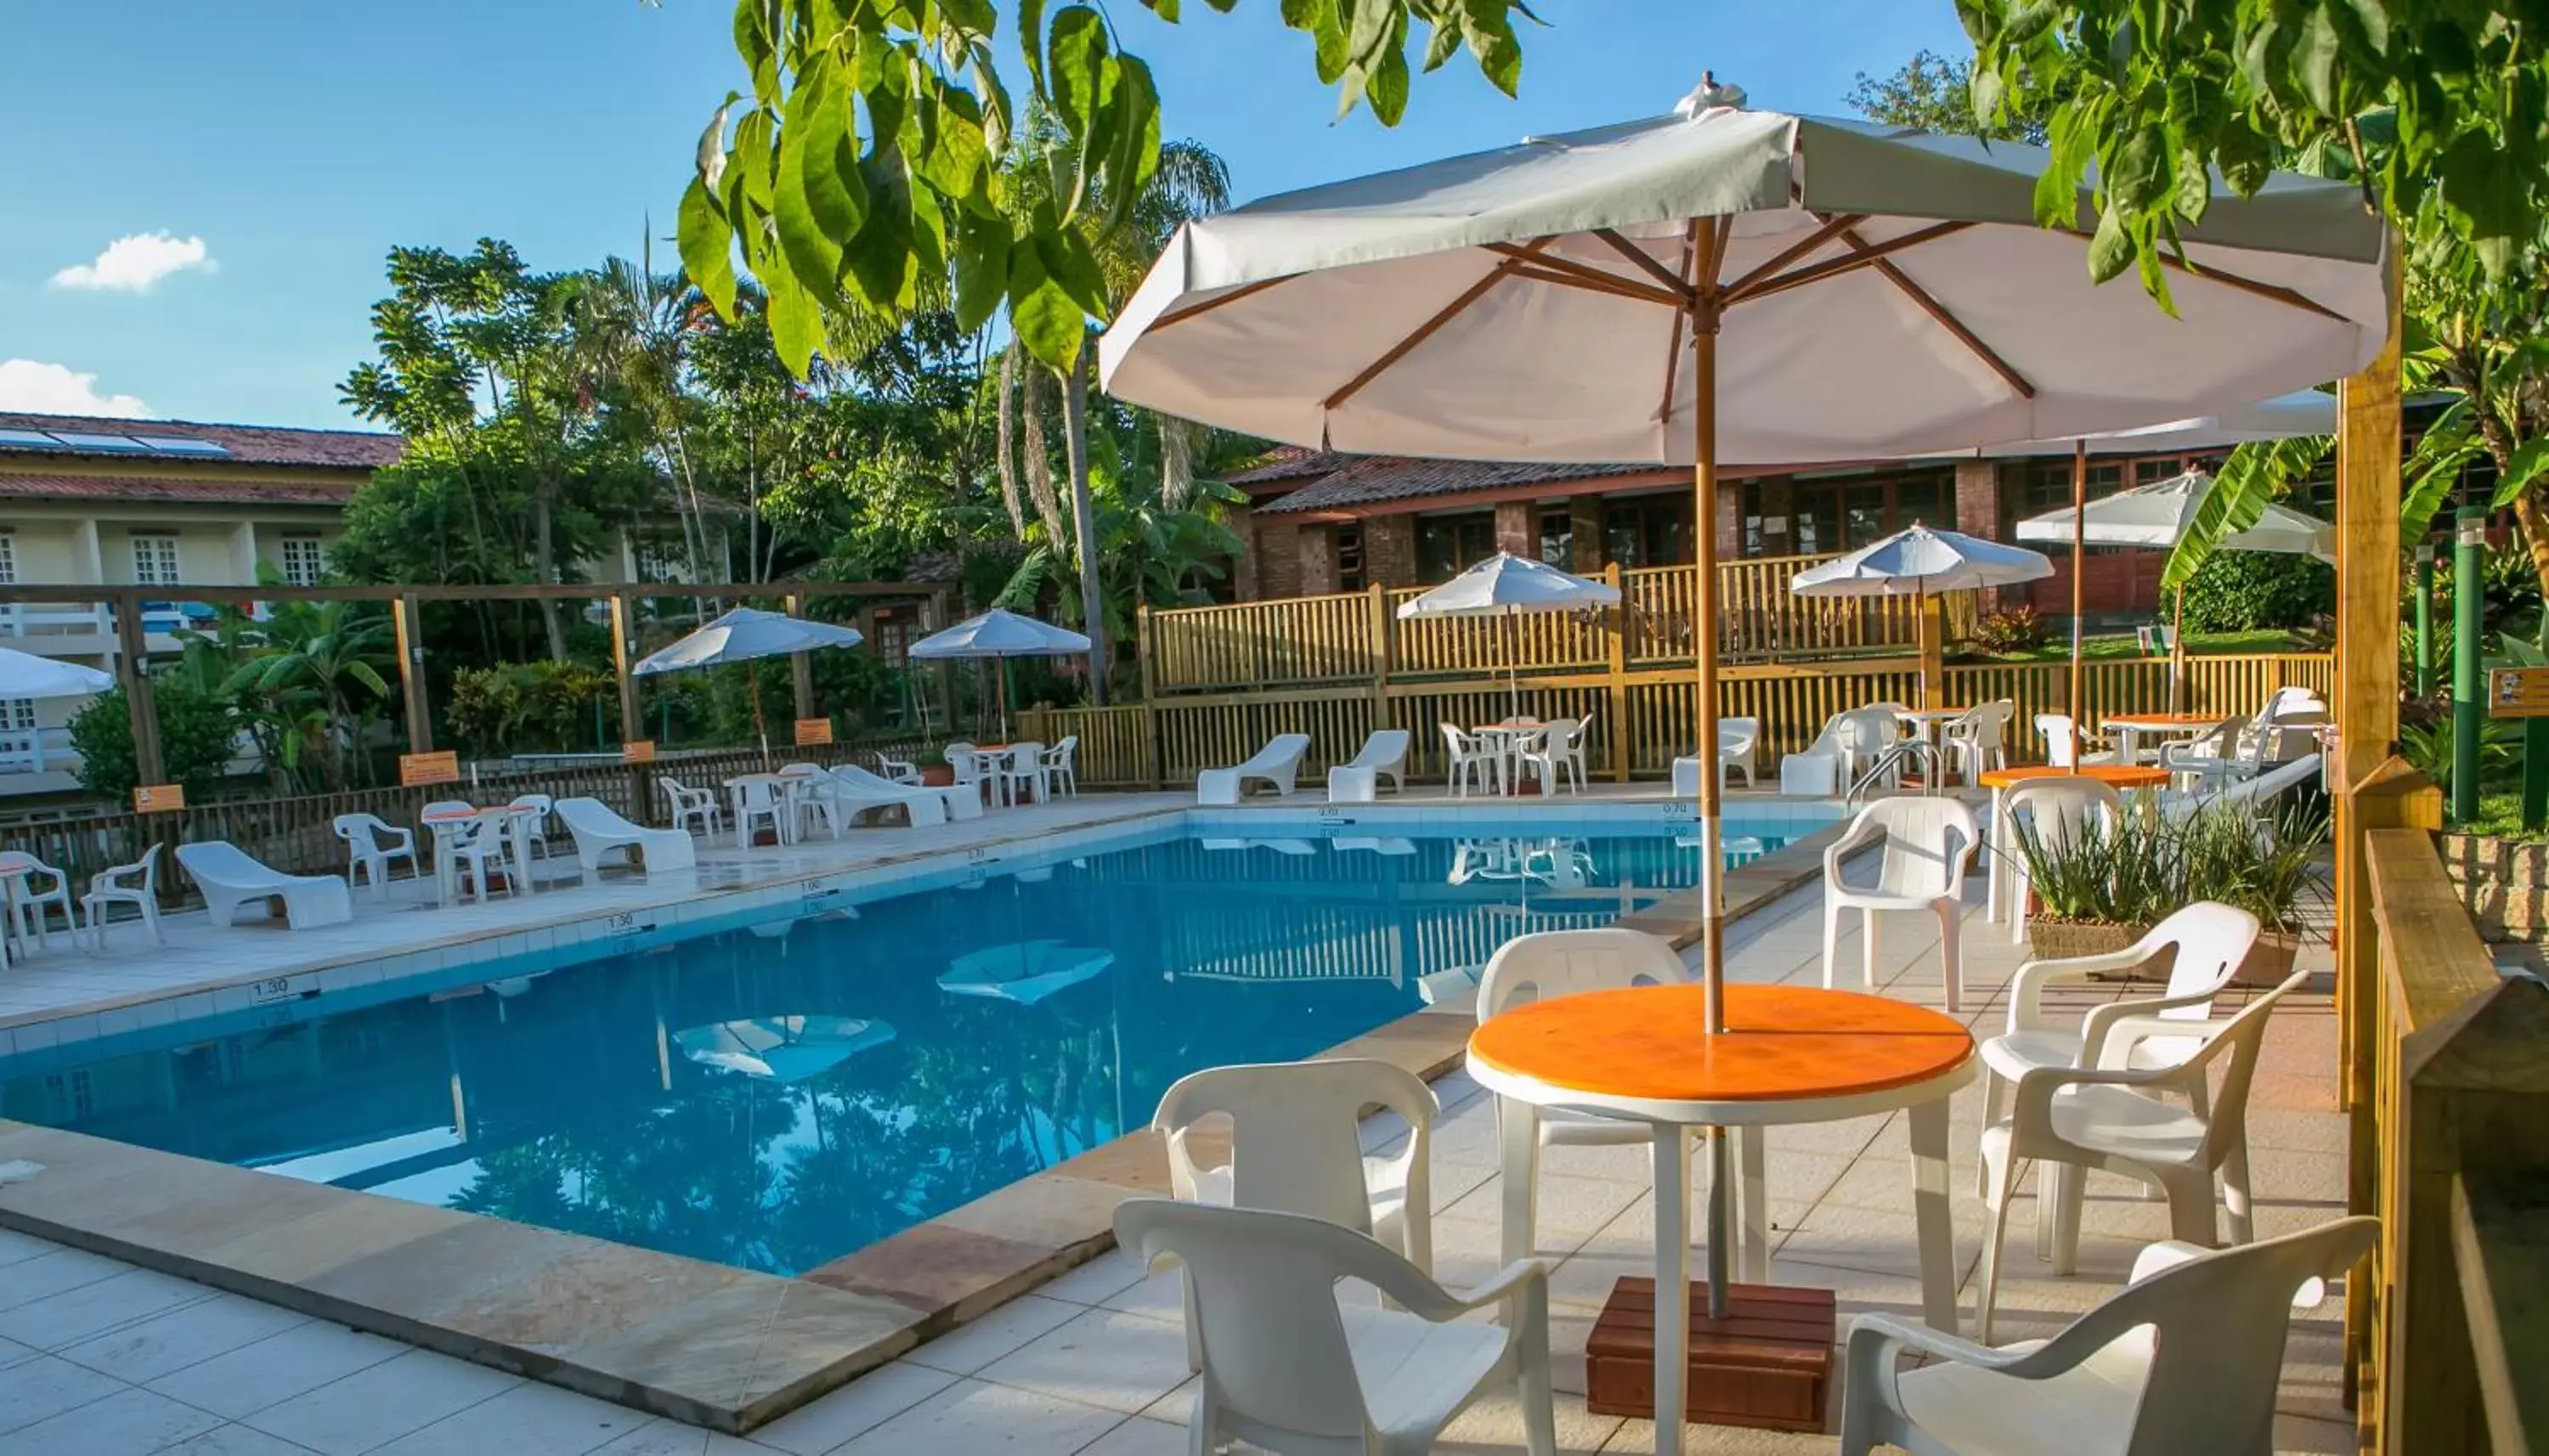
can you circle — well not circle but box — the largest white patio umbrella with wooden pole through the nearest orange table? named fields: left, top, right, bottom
left=1099, top=82, right=2391, bottom=1356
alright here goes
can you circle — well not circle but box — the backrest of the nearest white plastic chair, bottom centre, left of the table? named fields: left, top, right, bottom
left=1114, top=1199, right=1433, bottom=1451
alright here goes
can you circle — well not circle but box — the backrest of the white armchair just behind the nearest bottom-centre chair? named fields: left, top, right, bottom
left=1150, top=1058, right=1438, bottom=1234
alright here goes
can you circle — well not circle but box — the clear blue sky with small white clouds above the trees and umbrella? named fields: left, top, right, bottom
left=0, top=0, right=1965, bottom=426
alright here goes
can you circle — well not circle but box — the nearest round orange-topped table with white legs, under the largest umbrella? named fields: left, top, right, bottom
left=1468, top=985, right=1978, bottom=1453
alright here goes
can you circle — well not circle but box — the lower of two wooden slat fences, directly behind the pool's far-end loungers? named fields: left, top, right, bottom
left=1017, top=650, right=2332, bottom=788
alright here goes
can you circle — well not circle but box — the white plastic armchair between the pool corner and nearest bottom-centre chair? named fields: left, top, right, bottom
left=1150, top=1058, right=1440, bottom=1270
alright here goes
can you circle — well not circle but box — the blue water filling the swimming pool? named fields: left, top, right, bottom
left=0, top=819, right=1810, bottom=1273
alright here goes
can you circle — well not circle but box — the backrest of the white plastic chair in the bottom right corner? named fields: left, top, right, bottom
left=2011, top=1219, right=2381, bottom=1456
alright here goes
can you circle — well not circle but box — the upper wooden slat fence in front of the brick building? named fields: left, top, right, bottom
left=1142, top=556, right=1973, bottom=696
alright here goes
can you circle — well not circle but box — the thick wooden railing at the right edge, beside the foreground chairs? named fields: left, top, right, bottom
left=2340, top=785, right=2549, bottom=1456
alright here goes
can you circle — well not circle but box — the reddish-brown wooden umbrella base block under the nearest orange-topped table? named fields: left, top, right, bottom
left=1585, top=1280, right=1840, bottom=1433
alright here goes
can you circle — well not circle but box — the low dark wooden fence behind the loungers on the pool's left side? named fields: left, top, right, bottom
left=0, top=737, right=918, bottom=903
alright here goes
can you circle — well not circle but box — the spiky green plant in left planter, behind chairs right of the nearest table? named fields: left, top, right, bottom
left=2014, top=814, right=2187, bottom=974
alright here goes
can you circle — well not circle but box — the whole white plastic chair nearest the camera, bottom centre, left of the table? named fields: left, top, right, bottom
left=1114, top=1199, right=1557, bottom=1456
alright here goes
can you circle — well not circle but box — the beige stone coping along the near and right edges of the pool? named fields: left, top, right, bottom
left=0, top=804, right=1840, bottom=1433
